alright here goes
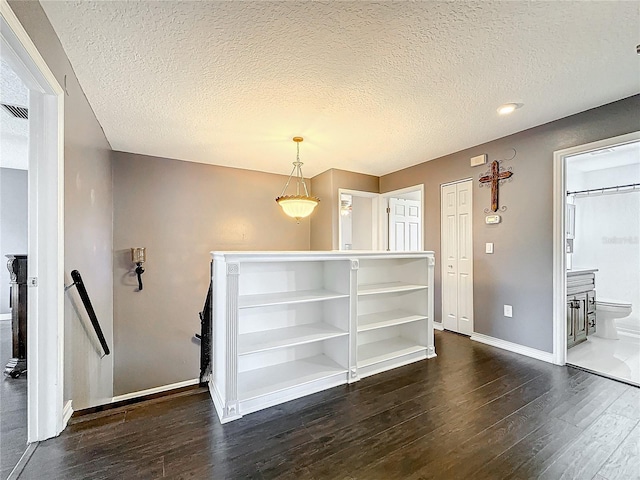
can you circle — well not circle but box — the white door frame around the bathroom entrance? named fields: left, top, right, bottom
left=553, top=131, right=640, bottom=365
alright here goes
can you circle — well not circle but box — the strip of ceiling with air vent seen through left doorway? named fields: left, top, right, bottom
left=0, top=60, right=29, bottom=170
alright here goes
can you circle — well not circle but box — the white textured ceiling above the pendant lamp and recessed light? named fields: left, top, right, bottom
left=42, top=1, right=640, bottom=176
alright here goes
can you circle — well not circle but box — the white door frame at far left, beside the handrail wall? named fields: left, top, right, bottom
left=0, top=0, right=68, bottom=443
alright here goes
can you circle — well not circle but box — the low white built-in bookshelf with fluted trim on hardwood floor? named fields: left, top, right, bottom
left=209, top=252, right=435, bottom=423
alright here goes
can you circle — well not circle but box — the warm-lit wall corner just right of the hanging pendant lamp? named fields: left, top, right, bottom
left=311, top=168, right=380, bottom=250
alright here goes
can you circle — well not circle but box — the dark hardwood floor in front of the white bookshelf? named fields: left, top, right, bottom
left=20, top=332, right=640, bottom=480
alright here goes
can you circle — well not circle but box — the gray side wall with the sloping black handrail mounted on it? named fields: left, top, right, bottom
left=9, top=1, right=113, bottom=410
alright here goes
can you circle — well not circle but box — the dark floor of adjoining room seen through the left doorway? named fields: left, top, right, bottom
left=0, top=320, right=27, bottom=480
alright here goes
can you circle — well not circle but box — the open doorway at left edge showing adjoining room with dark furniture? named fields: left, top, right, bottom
left=0, top=55, right=29, bottom=478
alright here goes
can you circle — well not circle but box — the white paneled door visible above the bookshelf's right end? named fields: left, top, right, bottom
left=388, top=197, right=422, bottom=252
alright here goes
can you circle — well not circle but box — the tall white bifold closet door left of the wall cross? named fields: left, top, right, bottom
left=441, top=180, right=473, bottom=335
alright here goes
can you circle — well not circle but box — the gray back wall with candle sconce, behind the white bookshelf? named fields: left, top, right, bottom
left=113, top=152, right=312, bottom=395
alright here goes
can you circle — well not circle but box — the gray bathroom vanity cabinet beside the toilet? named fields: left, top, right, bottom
left=567, top=269, right=597, bottom=348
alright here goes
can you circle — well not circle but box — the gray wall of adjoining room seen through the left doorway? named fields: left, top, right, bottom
left=0, top=168, right=28, bottom=313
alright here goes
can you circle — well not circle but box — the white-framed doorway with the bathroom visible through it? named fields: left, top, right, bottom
left=554, top=133, right=640, bottom=385
